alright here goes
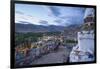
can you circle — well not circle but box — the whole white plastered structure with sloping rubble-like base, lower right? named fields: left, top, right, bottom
left=70, top=31, right=94, bottom=62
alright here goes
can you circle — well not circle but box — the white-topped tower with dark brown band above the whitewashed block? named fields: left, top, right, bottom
left=83, top=8, right=95, bottom=30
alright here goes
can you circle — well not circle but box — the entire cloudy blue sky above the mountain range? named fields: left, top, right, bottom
left=15, top=4, right=94, bottom=26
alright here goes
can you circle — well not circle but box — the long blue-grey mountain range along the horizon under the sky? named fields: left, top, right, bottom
left=15, top=23, right=79, bottom=33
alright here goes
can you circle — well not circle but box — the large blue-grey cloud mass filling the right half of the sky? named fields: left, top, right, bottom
left=49, top=6, right=85, bottom=26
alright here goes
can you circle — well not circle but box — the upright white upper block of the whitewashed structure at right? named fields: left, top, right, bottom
left=78, top=31, right=94, bottom=54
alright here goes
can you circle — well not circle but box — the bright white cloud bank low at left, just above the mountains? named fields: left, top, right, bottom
left=15, top=11, right=48, bottom=26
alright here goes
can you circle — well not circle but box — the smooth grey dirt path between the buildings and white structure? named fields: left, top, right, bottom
left=32, top=47, right=69, bottom=65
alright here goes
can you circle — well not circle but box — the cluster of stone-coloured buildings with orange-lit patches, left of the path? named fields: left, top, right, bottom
left=15, top=35, right=60, bottom=66
